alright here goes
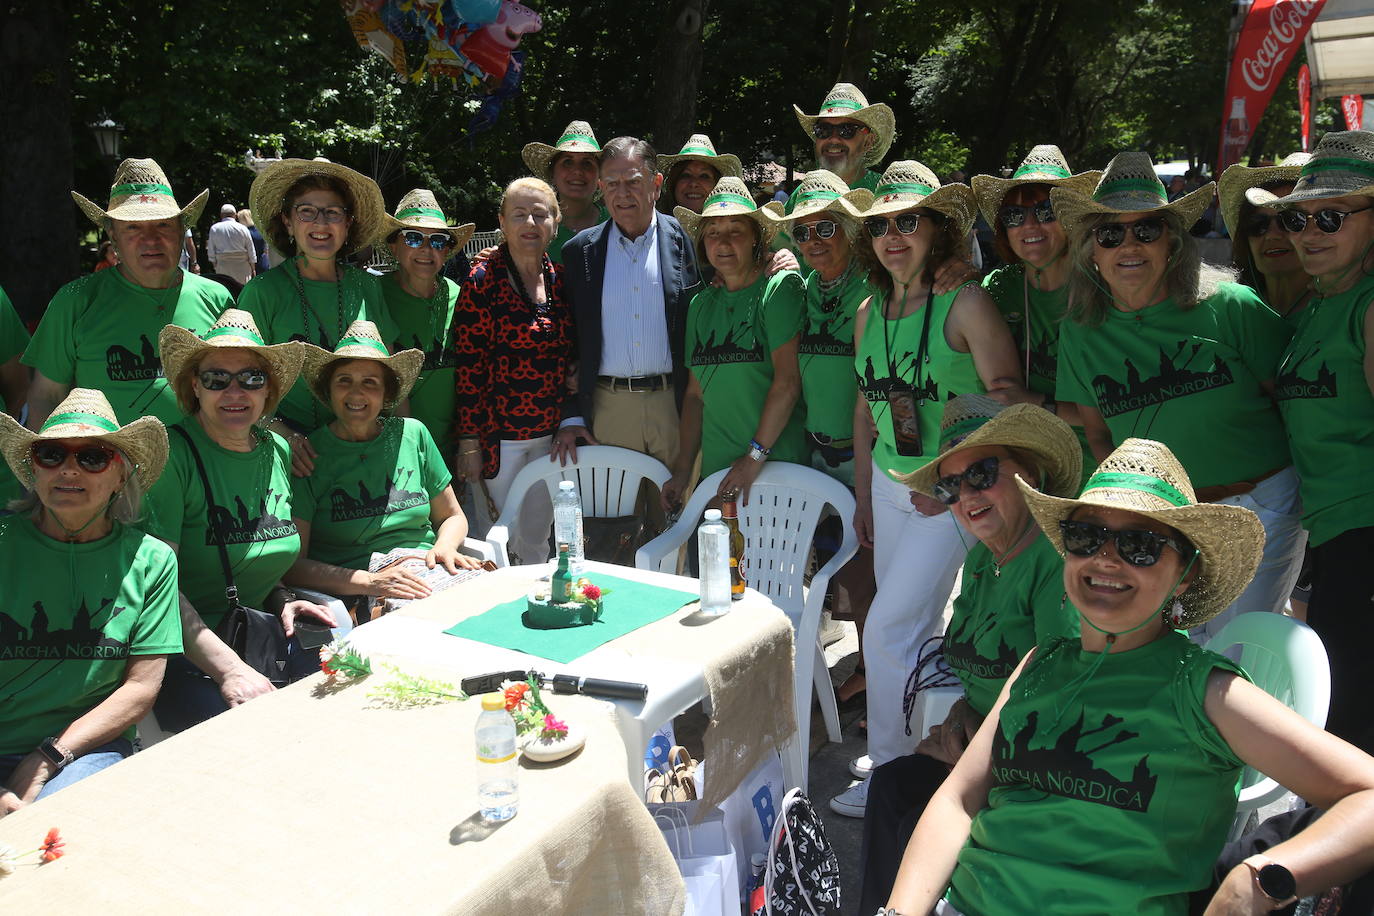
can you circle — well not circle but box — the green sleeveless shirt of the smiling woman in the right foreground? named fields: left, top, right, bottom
left=948, top=630, right=1242, bottom=916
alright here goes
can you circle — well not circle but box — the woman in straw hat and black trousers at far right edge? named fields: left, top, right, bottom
left=1268, top=130, right=1374, bottom=750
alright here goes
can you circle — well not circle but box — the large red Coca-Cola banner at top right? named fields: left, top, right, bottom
left=1216, top=0, right=1326, bottom=173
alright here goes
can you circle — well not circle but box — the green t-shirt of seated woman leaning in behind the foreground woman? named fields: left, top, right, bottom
left=943, top=534, right=1079, bottom=715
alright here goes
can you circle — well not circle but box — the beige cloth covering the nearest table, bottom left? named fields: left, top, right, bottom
left=0, top=673, right=686, bottom=916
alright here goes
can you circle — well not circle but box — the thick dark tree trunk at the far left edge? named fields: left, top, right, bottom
left=0, top=0, right=80, bottom=321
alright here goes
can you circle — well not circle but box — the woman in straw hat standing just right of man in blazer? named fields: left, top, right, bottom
left=662, top=177, right=808, bottom=512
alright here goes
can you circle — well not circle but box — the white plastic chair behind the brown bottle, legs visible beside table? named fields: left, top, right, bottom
left=635, top=461, right=859, bottom=787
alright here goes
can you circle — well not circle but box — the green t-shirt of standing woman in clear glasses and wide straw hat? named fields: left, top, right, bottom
left=239, top=260, right=396, bottom=433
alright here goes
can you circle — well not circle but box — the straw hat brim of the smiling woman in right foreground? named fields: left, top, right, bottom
left=1017, top=475, right=1264, bottom=629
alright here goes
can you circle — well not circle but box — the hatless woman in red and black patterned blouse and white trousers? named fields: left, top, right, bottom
left=453, top=179, right=573, bottom=563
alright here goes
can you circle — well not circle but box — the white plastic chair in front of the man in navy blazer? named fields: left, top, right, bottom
left=486, top=445, right=673, bottom=566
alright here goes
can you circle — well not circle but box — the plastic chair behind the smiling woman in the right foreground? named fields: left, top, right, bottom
left=1206, top=611, right=1331, bottom=839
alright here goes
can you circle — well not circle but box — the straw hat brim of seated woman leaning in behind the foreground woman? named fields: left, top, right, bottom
left=897, top=404, right=1083, bottom=496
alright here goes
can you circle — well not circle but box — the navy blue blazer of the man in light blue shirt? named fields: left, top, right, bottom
left=563, top=213, right=701, bottom=426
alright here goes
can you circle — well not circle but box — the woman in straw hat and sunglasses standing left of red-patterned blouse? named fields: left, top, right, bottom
left=382, top=188, right=477, bottom=463
